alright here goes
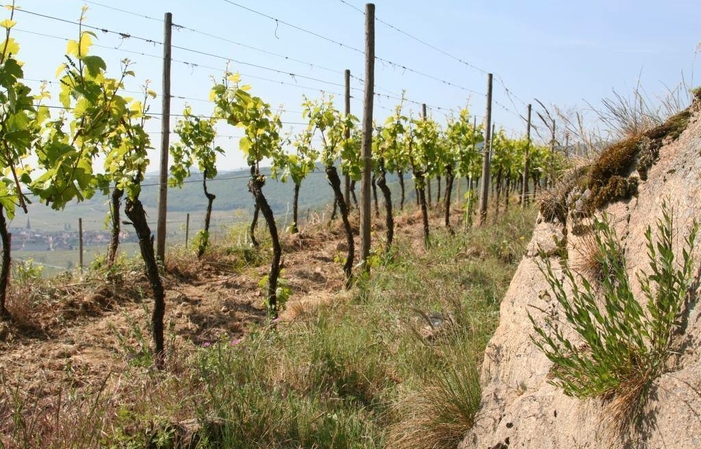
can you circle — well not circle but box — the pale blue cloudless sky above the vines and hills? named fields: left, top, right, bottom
left=2, top=0, right=701, bottom=170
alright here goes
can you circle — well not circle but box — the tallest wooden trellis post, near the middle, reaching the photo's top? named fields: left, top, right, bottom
left=360, top=3, right=375, bottom=270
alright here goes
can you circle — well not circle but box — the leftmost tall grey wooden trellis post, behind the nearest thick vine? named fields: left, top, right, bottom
left=156, top=12, right=173, bottom=261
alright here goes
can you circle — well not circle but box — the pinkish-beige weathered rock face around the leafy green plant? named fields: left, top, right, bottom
left=460, top=103, right=701, bottom=449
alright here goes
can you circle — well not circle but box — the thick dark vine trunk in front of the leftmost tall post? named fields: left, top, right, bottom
left=124, top=198, right=166, bottom=369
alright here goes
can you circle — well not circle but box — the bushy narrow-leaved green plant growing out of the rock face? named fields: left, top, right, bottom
left=529, top=205, right=698, bottom=426
